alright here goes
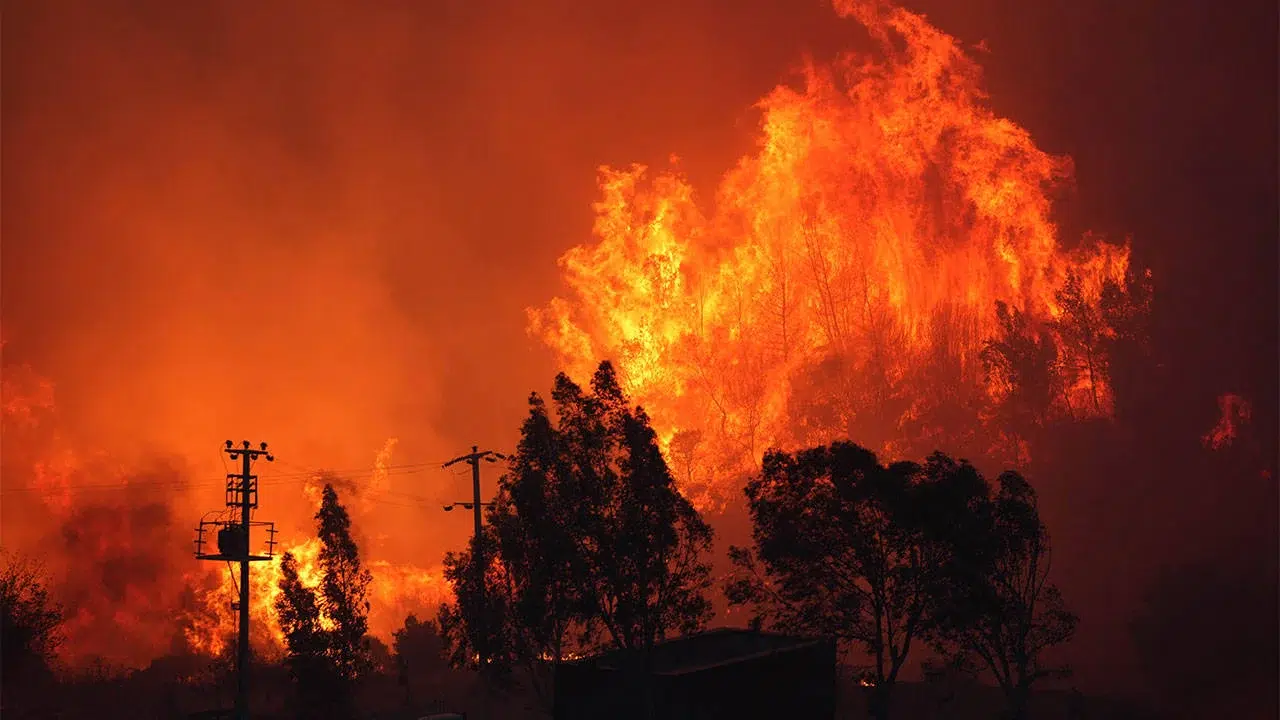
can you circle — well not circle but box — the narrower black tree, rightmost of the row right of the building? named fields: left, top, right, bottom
left=933, top=459, right=1078, bottom=720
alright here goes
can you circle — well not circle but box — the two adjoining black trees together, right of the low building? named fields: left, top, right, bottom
left=726, top=442, right=1075, bottom=717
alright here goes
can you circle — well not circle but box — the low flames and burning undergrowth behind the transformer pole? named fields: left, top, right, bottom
left=3, top=340, right=447, bottom=667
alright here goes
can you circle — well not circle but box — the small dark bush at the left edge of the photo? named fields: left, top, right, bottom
left=0, top=552, right=63, bottom=705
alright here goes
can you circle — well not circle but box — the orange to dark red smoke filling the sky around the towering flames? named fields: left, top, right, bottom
left=0, top=0, right=1280, bottom=696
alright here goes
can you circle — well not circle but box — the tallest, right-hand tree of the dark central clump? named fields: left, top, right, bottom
left=550, top=363, right=712, bottom=650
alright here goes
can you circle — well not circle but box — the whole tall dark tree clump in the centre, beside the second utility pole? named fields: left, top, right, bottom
left=442, top=363, right=712, bottom=702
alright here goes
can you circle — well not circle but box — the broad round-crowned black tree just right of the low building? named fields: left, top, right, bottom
left=726, top=442, right=980, bottom=719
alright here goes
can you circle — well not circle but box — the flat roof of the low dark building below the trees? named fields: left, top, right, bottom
left=560, top=628, right=828, bottom=675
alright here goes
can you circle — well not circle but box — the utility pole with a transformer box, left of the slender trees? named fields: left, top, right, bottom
left=196, top=441, right=275, bottom=720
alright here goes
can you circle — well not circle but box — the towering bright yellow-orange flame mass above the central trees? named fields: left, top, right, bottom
left=529, top=0, right=1129, bottom=503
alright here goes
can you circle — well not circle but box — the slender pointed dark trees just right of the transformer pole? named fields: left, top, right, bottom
left=275, top=483, right=372, bottom=717
